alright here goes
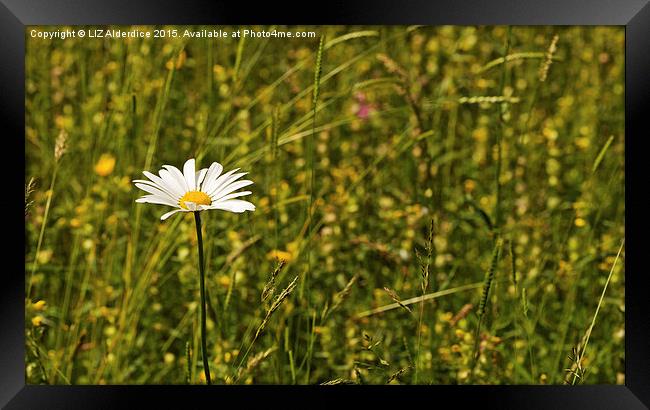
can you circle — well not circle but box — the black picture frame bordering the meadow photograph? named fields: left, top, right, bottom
left=5, top=0, right=650, bottom=409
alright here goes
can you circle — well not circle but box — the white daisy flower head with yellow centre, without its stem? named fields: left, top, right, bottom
left=133, top=158, right=255, bottom=221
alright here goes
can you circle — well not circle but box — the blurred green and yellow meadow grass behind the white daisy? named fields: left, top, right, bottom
left=25, top=26, right=625, bottom=384
